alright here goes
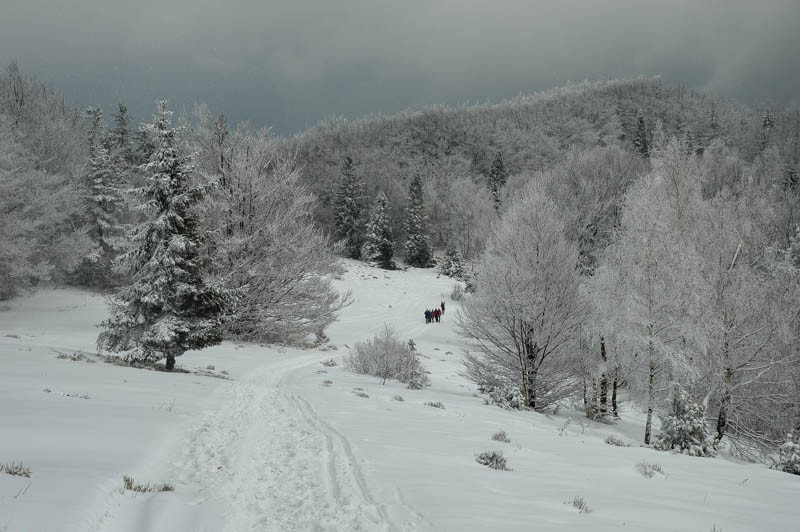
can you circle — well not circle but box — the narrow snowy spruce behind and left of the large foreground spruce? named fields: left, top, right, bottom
left=75, top=107, right=125, bottom=288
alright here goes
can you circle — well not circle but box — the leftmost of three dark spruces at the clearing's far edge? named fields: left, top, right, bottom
left=333, top=157, right=363, bottom=259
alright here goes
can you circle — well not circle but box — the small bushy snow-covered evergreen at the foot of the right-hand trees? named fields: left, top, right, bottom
left=653, top=386, right=717, bottom=456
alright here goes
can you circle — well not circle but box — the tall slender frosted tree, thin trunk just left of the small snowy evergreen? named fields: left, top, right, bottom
left=589, top=141, right=702, bottom=444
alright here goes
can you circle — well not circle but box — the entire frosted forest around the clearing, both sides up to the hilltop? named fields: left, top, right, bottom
left=0, top=63, right=800, bottom=473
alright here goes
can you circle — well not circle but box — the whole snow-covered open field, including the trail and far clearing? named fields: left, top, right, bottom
left=0, top=262, right=800, bottom=532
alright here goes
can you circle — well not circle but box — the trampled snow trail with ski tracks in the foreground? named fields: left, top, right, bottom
left=174, top=357, right=397, bottom=531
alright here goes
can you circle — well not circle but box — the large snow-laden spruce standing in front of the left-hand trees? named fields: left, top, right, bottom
left=97, top=101, right=231, bottom=370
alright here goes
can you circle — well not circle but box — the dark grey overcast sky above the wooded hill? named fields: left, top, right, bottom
left=0, top=0, right=800, bottom=134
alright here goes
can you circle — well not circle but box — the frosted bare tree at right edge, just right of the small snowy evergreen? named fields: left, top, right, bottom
left=695, top=194, right=798, bottom=455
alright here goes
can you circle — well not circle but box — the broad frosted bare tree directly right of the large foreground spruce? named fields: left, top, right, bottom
left=194, top=108, right=349, bottom=343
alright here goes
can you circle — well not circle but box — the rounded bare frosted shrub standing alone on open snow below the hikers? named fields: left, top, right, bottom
left=344, top=325, right=430, bottom=389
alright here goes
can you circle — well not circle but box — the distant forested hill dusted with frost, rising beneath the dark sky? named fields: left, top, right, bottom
left=285, top=79, right=800, bottom=256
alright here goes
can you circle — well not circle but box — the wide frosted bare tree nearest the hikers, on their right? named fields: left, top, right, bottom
left=457, top=182, right=587, bottom=410
